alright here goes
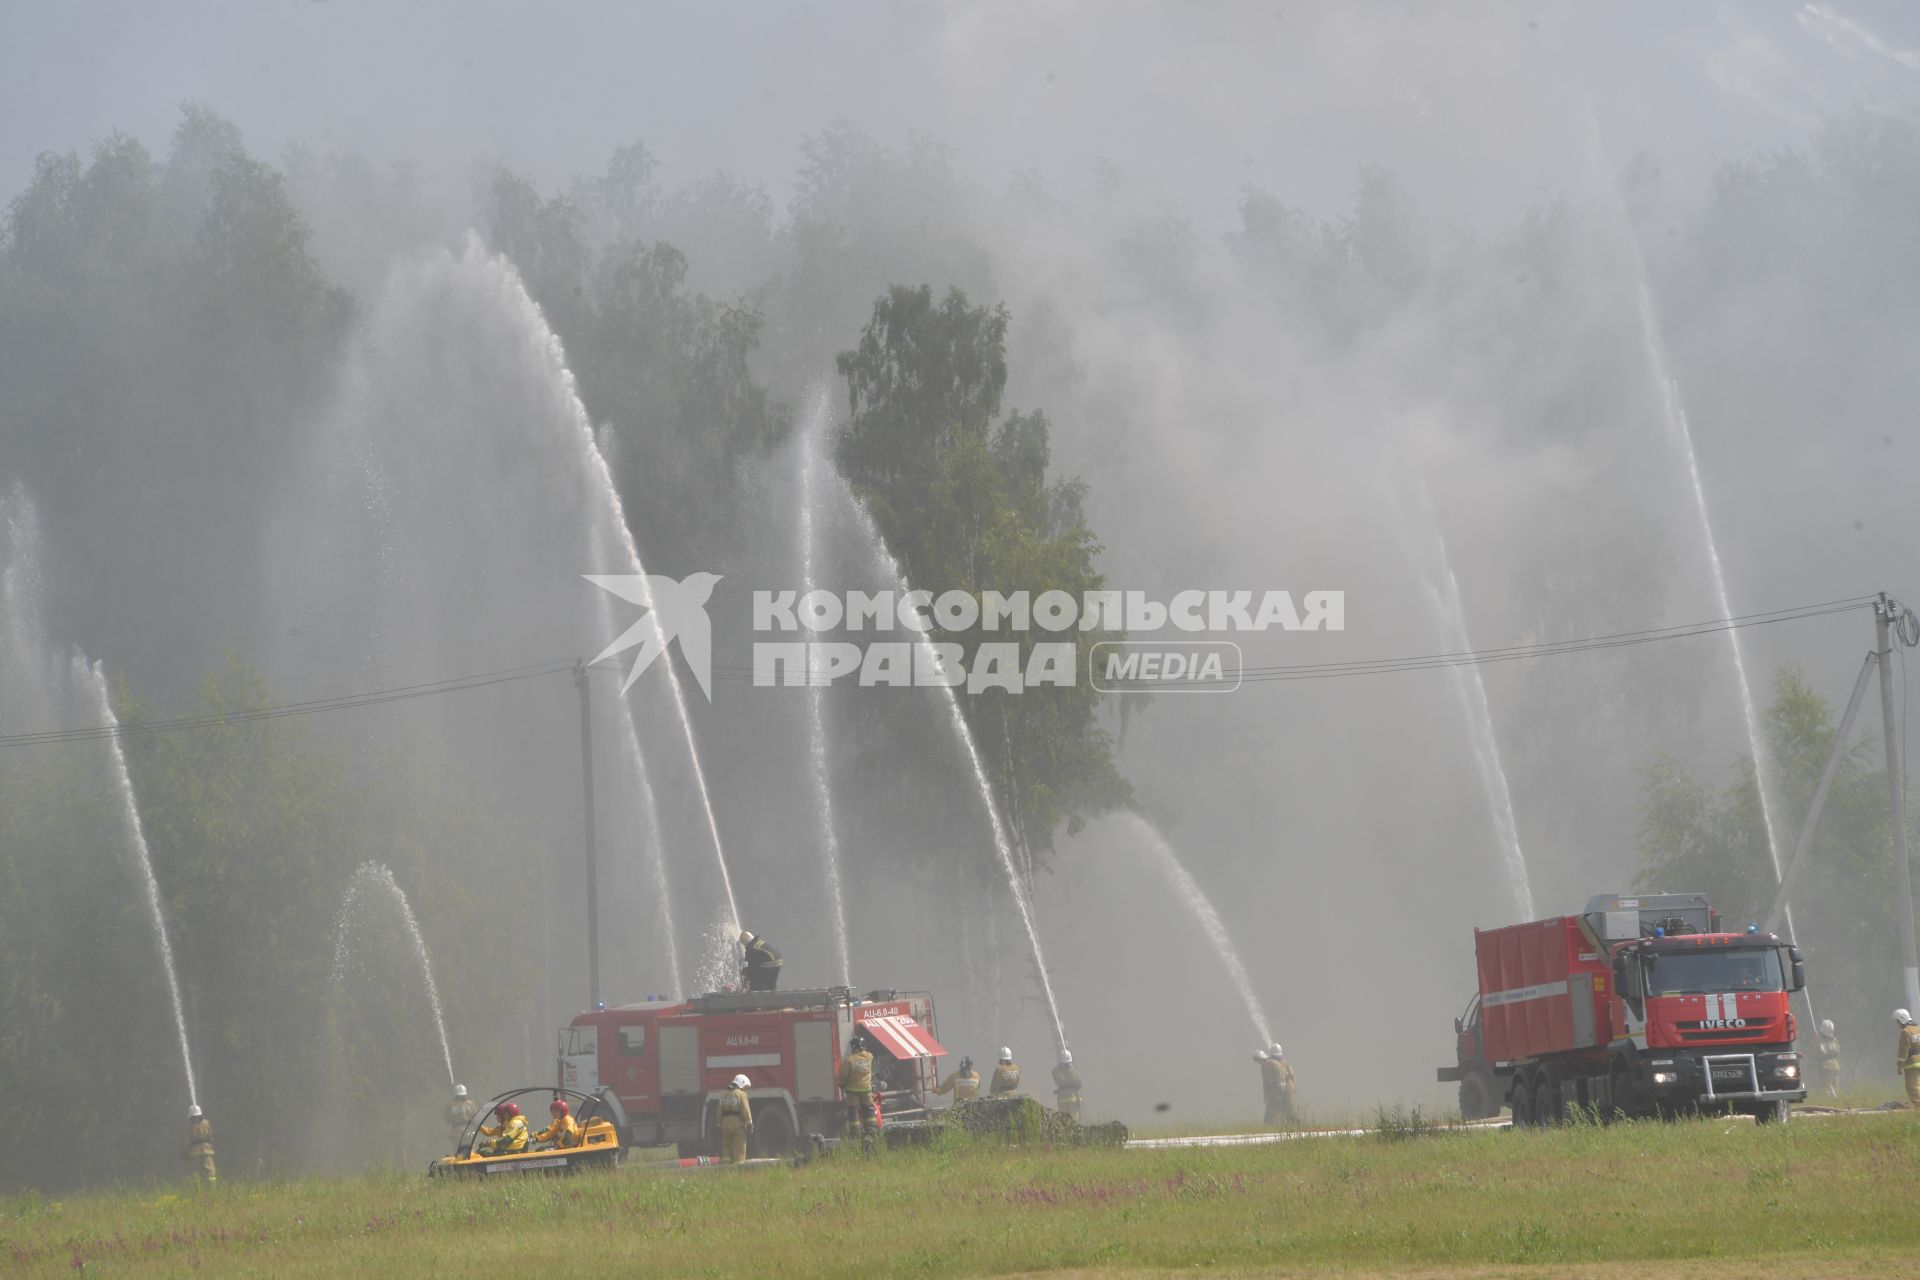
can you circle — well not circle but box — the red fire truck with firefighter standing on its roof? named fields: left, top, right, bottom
left=559, top=986, right=947, bottom=1155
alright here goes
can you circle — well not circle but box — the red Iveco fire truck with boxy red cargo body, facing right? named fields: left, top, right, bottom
left=1438, top=894, right=1807, bottom=1126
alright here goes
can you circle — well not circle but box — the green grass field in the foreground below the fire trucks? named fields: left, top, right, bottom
left=0, top=1113, right=1920, bottom=1280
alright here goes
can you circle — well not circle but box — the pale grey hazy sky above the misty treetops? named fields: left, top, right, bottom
left=0, top=0, right=1920, bottom=223
